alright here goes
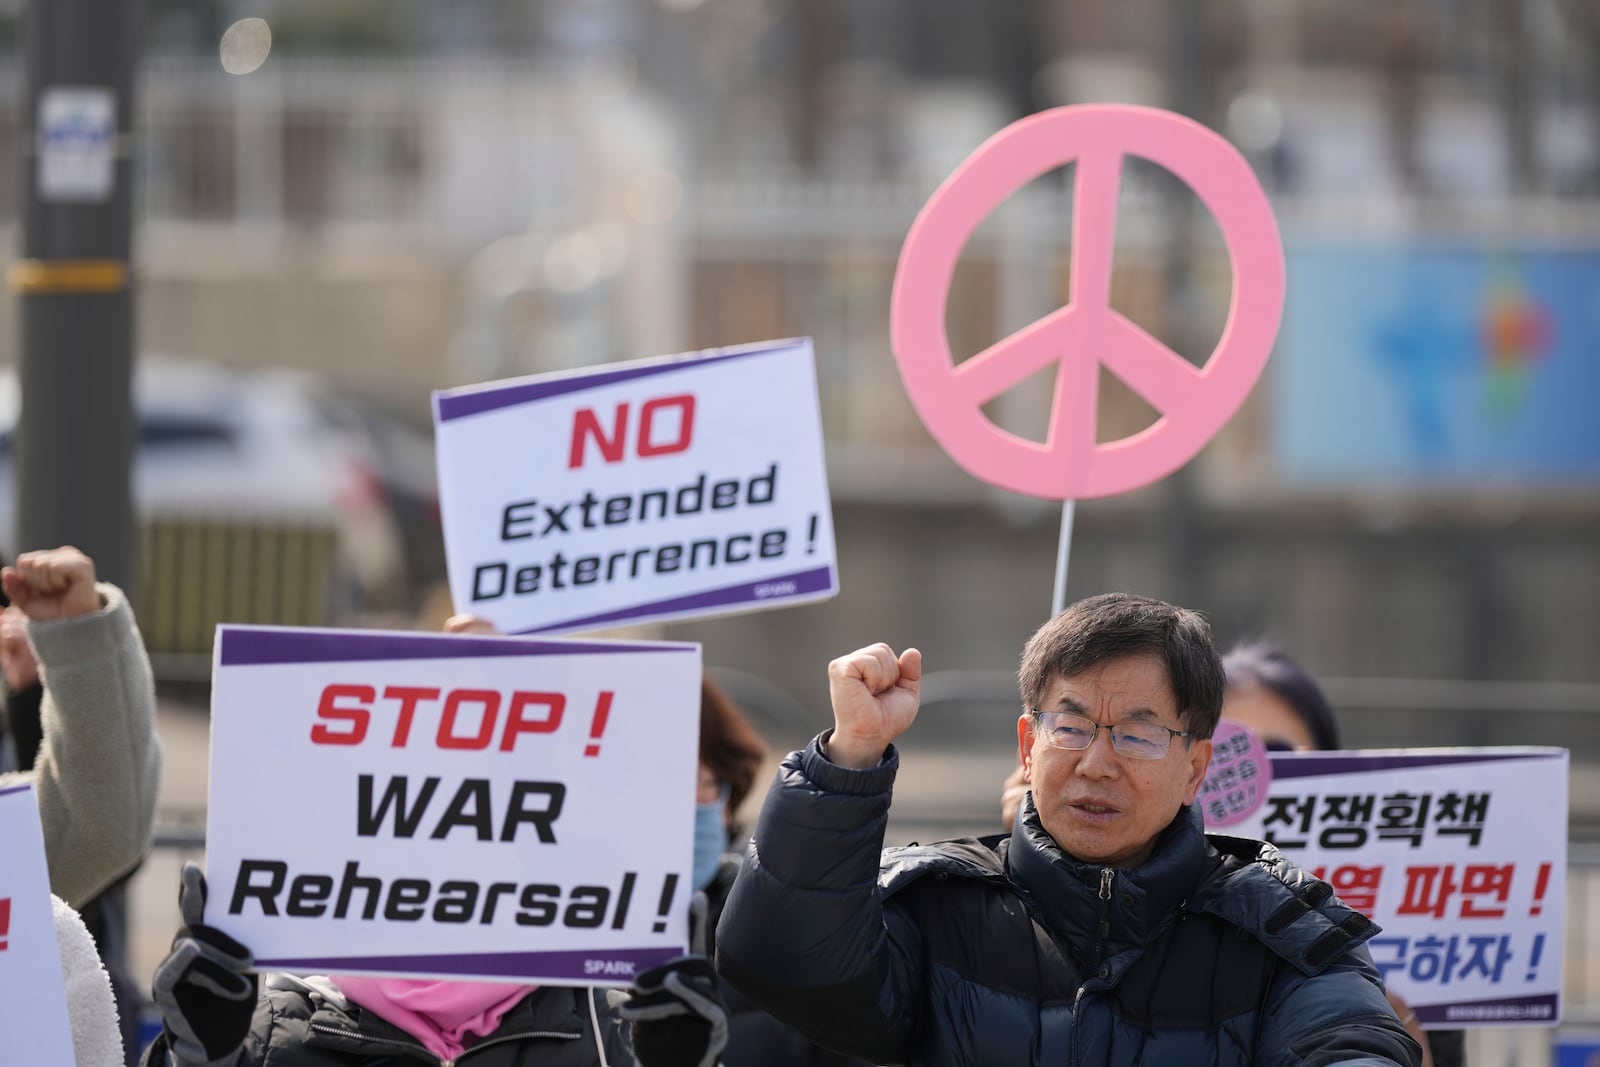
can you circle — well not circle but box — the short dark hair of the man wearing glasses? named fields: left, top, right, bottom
left=1018, top=593, right=1224, bottom=739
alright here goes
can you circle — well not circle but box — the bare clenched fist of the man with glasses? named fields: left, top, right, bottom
left=827, top=641, right=922, bottom=769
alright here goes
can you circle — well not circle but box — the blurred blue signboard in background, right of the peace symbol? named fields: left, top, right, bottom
left=1274, top=245, right=1600, bottom=485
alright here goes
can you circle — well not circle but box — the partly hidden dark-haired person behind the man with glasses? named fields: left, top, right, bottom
left=1222, top=641, right=1467, bottom=1067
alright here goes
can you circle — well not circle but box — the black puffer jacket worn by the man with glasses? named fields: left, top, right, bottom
left=717, top=741, right=1421, bottom=1067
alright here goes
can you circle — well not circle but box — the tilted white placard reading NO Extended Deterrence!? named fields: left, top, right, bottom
left=434, top=339, right=838, bottom=633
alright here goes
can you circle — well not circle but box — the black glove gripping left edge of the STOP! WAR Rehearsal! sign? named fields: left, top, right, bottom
left=150, top=862, right=258, bottom=1067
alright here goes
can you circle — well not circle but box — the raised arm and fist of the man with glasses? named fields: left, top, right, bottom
left=717, top=645, right=923, bottom=1064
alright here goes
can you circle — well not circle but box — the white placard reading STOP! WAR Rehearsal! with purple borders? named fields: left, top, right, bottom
left=206, top=625, right=701, bottom=985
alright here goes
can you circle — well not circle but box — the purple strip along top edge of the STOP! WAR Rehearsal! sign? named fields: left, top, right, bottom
left=218, top=627, right=694, bottom=667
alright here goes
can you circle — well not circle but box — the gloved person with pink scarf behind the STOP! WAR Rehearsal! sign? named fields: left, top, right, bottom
left=144, top=614, right=732, bottom=1067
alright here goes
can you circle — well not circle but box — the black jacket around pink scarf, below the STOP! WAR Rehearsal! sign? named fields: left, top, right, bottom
left=144, top=974, right=634, bottom=1067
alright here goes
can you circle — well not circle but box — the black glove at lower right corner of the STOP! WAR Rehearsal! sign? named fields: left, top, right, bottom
left=618, top=957, right=728, bottom=1067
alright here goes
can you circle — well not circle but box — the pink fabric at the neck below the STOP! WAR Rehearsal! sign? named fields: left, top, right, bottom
left=331, top=974, right=539, bottom=1059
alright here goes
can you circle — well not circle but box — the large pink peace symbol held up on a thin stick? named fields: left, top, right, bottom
left=891, top=106, right=1283, bottom=501
